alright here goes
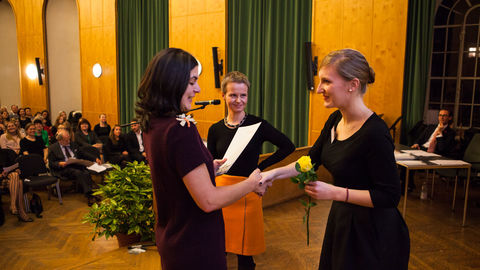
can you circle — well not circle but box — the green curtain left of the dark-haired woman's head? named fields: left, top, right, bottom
left=117, top=0, right=168, bottom=123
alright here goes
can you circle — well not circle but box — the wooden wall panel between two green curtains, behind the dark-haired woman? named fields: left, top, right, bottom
left=169, top=0, right=226, bottom=139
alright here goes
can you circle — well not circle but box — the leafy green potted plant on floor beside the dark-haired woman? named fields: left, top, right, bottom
left=83, top=161, right=155, bottom=246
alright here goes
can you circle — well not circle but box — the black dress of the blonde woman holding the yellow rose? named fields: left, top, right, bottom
left=310, top=111, right=410, bottom=269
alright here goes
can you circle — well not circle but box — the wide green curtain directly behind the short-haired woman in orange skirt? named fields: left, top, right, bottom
left=227, top=0, right=312, bottom=152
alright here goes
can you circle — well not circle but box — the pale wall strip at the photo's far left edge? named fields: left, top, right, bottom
left=0, top=1, right=21, bottom=110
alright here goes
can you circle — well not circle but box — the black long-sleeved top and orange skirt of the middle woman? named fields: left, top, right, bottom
left=207, top=115, right=295, bottom=255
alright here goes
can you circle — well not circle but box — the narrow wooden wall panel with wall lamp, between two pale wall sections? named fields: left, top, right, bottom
left=9, top=0, right=48, bottom=113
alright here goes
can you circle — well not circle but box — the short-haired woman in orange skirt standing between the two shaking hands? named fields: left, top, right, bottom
left=207, top=71, right=295, bottom=269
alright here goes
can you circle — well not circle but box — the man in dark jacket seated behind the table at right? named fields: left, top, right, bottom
left=411, top=109, right=455, bottom=156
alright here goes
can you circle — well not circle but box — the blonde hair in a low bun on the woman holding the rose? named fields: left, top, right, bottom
left=319, top=49, right=375, bottom=94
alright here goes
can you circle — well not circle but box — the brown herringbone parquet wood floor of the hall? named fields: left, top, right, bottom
left=0, top=178, right=480, bottom=270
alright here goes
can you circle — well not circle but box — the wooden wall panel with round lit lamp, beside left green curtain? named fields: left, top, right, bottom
left=77, top=0, right=119, bottom=126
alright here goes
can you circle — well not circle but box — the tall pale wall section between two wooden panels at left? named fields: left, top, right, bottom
left=45, top=0, right=82, bottom=118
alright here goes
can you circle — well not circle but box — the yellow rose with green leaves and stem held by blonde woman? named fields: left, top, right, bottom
left=290, top=156, right=317, bottom=246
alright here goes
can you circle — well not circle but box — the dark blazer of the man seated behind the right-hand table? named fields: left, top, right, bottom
left=414, top=125, right=455, bottom=156
